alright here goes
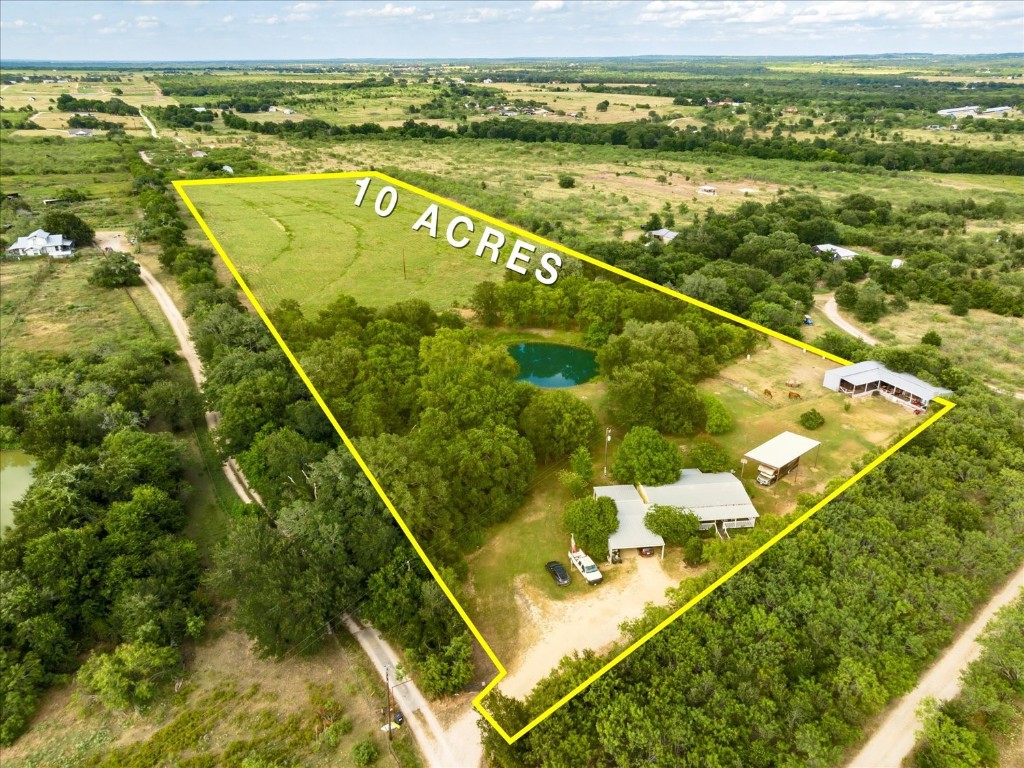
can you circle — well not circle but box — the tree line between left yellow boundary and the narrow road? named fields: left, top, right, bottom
left=123, top=162, right=483, bottom=694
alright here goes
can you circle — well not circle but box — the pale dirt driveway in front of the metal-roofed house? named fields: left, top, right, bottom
left=498, top=553, right=679, bottom=698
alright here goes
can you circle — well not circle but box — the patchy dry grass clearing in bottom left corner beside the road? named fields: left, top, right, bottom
left=4, top=620, right=421, bottom=768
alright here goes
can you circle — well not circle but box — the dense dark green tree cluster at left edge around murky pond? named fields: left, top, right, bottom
left=0, top=342, right=207, bottom=744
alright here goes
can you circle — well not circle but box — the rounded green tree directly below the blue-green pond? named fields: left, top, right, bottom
left=519, top=390, right=597, bottom=462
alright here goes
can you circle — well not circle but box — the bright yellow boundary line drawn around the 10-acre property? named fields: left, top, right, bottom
left=173, top=171, right=954, bottom=743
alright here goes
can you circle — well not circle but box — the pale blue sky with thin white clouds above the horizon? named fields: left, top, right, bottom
left=0, top=0, right=1024, bottom=61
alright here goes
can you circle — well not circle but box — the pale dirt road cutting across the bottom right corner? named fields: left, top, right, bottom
left=847, top=565, right=1024, bottom=768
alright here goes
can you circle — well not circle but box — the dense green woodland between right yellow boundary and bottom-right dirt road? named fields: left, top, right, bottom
left=484, top=376, right=1024, bottom=766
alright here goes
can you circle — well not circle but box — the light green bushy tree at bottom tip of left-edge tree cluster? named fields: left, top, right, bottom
left=78, top=642, right=181, bottom=711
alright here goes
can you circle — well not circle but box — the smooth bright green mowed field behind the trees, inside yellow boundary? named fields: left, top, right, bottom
left=180, top=178, right=557, bottom=313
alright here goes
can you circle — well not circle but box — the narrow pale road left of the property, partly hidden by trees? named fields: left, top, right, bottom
left=128, top=232, right=483, bottom=768
